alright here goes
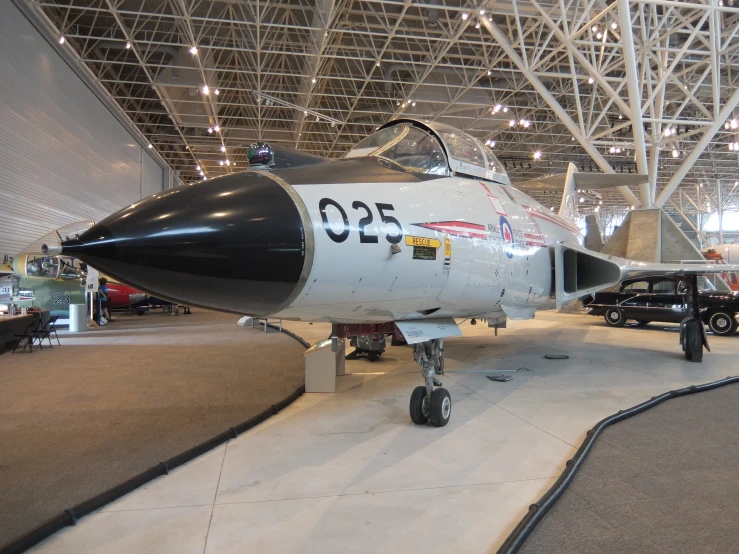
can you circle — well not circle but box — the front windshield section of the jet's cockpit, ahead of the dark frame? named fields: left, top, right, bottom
left=346, top=123, right=449, bottom=175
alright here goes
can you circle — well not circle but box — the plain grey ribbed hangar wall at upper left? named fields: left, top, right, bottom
left=0, top=1, right=169, bottom=261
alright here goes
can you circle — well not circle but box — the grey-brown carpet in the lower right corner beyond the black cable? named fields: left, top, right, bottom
left=520, top=384, right=739, bottom=554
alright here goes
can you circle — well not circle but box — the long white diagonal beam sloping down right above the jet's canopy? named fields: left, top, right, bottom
left=482, top=18, right=641, bottom=207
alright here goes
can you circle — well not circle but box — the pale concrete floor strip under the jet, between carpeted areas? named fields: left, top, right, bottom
left=27, top=313, right=739, bottom=554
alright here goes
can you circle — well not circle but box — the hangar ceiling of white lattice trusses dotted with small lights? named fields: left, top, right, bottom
left=15, top=0, right=739, bottom=225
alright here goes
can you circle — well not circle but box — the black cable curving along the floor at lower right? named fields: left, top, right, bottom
left=498, top=370, right=739, bottom=554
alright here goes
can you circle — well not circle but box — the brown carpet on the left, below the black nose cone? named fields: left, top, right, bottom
left=0, top=310, right=304, bottom=546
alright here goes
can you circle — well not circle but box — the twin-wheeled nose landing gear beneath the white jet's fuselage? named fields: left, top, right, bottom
left=410, top=339, right=452, bottom=427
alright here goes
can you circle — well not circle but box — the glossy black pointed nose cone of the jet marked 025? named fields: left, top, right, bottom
left=62, top=172, right=310, bottom=315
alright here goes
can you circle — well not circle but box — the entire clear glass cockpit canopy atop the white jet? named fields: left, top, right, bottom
left=345, top=119, right=510, bottom=185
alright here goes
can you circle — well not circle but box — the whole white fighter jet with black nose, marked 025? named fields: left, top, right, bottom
left=47, top=119, right=739, bottom=426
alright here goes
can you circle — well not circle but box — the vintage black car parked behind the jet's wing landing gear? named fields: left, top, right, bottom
left=583, top=276, right=739, bottom=335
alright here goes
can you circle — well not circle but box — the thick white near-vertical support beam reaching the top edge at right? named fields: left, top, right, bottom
left=618, top=0, right=656, bottom=208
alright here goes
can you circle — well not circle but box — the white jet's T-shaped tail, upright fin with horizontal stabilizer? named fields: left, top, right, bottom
left=515, top=163, right=648, bottom=221
